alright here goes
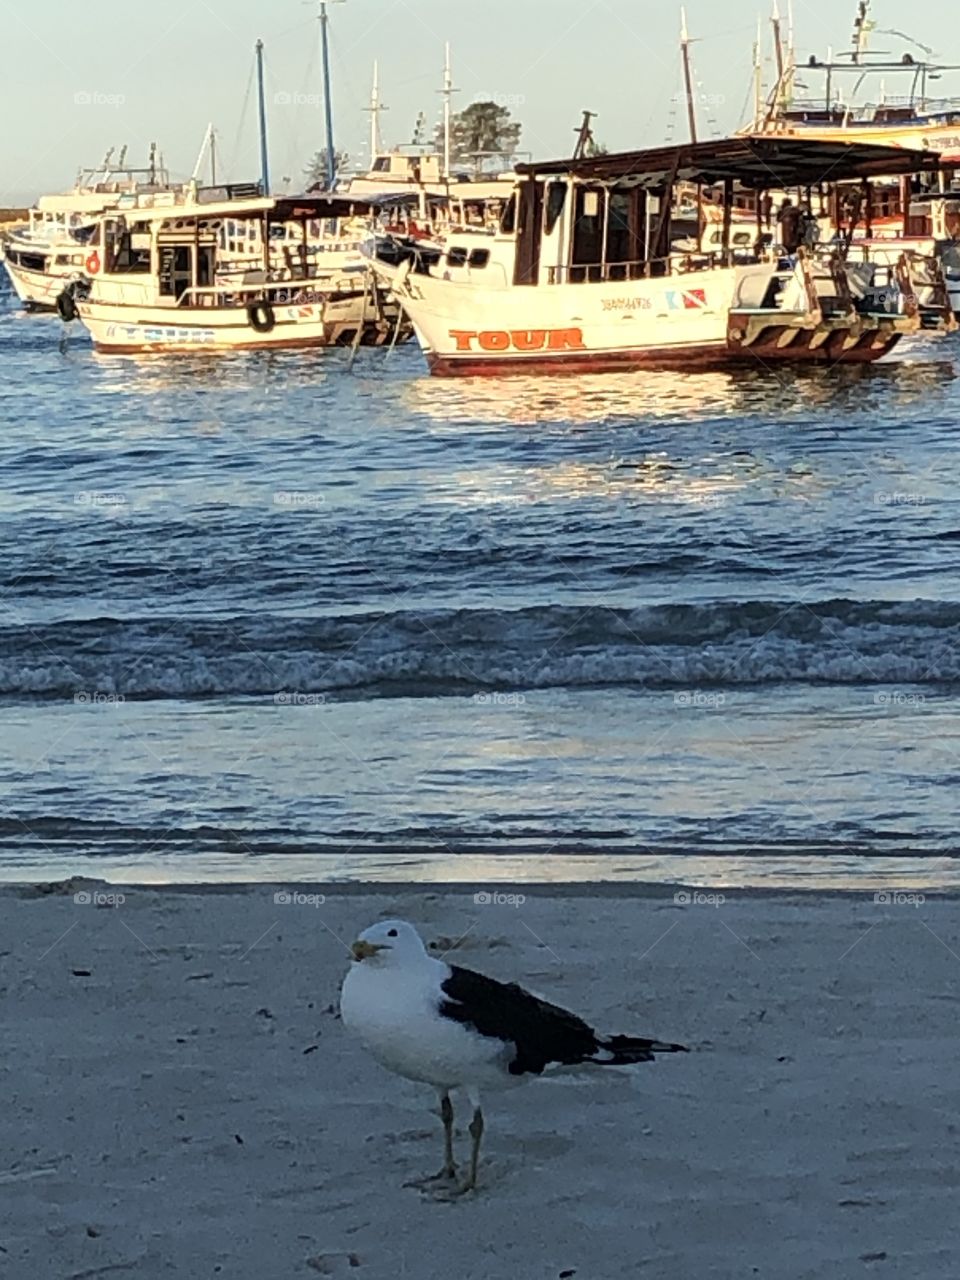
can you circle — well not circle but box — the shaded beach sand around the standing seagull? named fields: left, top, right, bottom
left=0, top=886, right=960, bottom=1280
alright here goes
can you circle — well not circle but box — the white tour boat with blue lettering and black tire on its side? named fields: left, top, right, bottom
left=58, top=187, right=401, bottom=353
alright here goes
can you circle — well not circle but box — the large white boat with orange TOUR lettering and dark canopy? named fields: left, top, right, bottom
left=372, top=137, right=955, bottom=376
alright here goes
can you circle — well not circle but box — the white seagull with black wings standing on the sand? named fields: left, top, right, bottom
left=340, top=920, right=687, bottom=1196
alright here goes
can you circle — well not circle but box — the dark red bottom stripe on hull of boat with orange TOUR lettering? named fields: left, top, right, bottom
left=426, top=329, right=901, bottom=378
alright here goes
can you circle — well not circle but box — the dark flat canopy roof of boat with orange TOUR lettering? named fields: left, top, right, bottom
left=517, top=137, right=940, bottom=191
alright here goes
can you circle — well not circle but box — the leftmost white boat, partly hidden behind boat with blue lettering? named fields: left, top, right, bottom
left=0, top=143, right=179, bottom=311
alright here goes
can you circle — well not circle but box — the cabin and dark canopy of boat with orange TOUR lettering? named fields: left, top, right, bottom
left=445, top=137, right=938, bottom=287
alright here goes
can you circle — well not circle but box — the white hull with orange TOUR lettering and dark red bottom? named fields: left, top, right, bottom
left=376, top=264, right=919, bottom=378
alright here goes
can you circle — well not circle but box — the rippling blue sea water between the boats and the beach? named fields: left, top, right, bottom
left=0, top=275, right=960, bottom=884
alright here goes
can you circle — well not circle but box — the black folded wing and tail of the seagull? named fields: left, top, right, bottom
left=440, top=965, right=684, bottom=1075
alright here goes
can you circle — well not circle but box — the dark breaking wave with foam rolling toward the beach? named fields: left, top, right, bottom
left=0, top=599, right=960, bottom=699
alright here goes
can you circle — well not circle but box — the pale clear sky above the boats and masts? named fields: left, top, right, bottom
left=0, top=0, right=960, bottom=206
